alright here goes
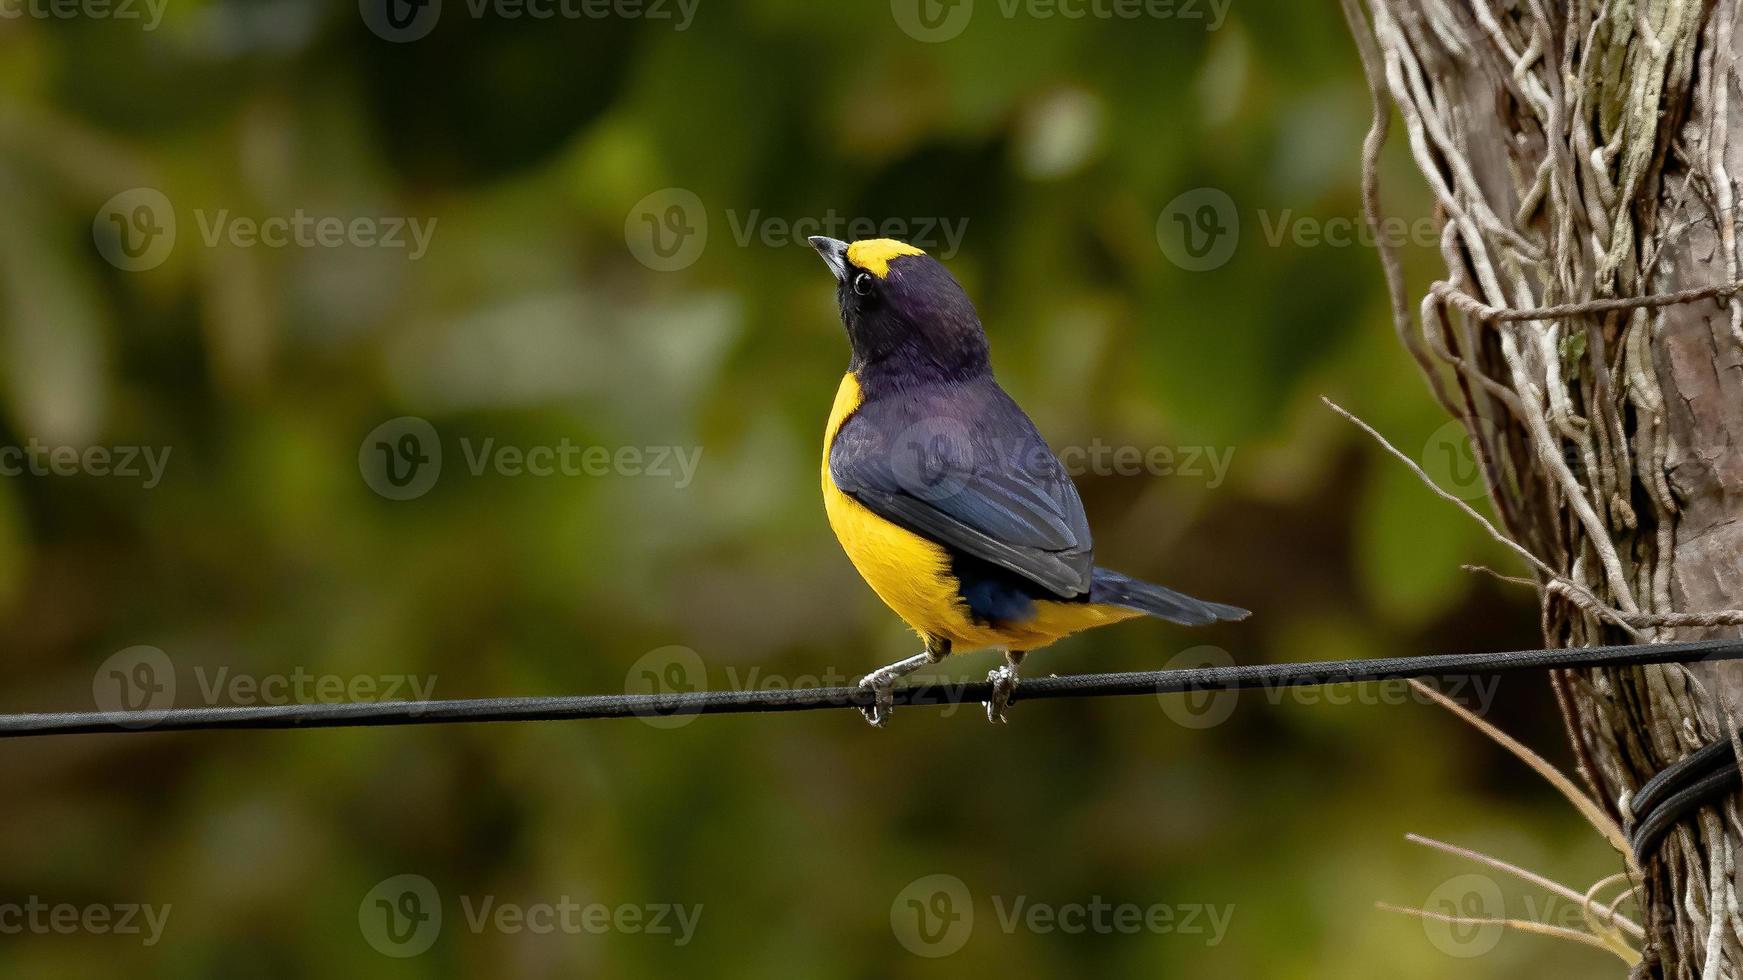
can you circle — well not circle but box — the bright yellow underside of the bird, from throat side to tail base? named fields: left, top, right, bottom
left=823, top=373, right=1142, bottom=652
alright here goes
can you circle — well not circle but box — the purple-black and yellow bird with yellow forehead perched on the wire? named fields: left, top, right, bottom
left=807, top=235, right=1248, bottom=727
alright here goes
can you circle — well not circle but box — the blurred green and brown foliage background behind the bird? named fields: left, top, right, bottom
left=0, top=0, right=1619, bottom=978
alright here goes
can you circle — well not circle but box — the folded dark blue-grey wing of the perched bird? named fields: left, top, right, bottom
left=830, top=378, right=1093, bottom=598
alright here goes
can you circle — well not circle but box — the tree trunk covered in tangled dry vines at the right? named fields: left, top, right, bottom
left=1344, top=0, right=1743, bottom=978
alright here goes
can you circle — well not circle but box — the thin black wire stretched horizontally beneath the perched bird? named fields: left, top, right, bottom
left=10, top=640, right=1743, bottom=738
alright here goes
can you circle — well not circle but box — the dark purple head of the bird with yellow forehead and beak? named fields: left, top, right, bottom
left=810, top=235, right=988, bottom=380
